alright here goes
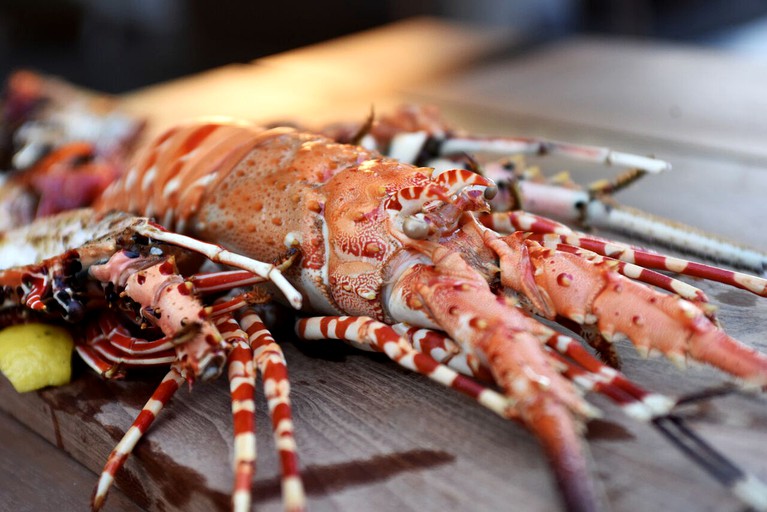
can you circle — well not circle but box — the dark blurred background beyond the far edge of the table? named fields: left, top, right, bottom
left=0, top=0, right=767, bottom=93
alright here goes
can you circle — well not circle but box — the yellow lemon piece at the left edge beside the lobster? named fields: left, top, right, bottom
left=0, top=323, right=74, bottom=393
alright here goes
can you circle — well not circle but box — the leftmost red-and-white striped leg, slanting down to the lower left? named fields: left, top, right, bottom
left=91, top=367, right=185, bottom=510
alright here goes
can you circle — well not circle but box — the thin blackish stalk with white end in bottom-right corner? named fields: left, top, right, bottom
left=652, top=415, right=767, bottom=512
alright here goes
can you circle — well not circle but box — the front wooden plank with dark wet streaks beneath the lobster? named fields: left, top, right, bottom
left=0, top=308, right=767, bottom=512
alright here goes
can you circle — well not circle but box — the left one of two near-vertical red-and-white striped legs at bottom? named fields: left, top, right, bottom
left=216, top=315, right=256, bottom=512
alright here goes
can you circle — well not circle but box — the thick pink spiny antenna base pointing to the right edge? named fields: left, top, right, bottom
left=484, top=231, right=767, bottom=387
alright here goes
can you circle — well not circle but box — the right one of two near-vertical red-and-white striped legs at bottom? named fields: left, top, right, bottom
left=240, top=309, right=306, bottom=512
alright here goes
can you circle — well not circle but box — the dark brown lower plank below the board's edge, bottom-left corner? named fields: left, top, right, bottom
left=0, top=408, right=142, bottom=512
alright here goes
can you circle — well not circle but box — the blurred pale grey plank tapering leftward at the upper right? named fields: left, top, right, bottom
left=414, top=38, right=767, bottom=159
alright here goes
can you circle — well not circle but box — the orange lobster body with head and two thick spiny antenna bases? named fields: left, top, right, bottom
left=87, top=119, right=767, bottom=509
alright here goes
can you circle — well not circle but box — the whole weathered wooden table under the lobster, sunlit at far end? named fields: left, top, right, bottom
left=0, top=20, right=767, bottom=511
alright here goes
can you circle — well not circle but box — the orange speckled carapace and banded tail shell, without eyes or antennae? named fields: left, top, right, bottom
left=98, top=123, right=431, bottom=318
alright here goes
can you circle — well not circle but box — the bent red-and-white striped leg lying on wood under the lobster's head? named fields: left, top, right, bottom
left=296, top=316, right=516, bottom=418
